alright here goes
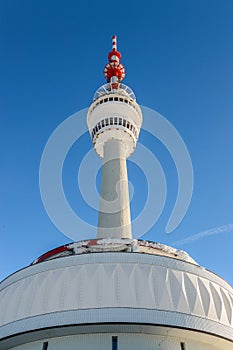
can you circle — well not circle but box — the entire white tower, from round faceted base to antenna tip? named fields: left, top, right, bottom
left=0, top=37, right=233, bottom=350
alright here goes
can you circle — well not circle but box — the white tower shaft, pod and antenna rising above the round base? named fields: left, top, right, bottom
left=87, top=36, right=142, bottom=238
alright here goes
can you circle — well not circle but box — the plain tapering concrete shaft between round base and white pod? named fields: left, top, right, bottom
left=98, top=139, right=132, bottom=238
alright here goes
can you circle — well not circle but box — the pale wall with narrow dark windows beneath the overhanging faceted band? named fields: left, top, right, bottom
left=8, top=333, right=232, bottom=350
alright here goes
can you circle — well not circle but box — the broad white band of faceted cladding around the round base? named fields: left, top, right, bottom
left=0, top=253, right=233, bottom=340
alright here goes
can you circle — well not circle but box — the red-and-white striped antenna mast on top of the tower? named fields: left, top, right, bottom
left=104, top=35, right=125, bottom=90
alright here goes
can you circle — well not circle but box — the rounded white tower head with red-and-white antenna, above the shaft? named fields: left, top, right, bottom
left=87, top=36, right=142, bottom=158
